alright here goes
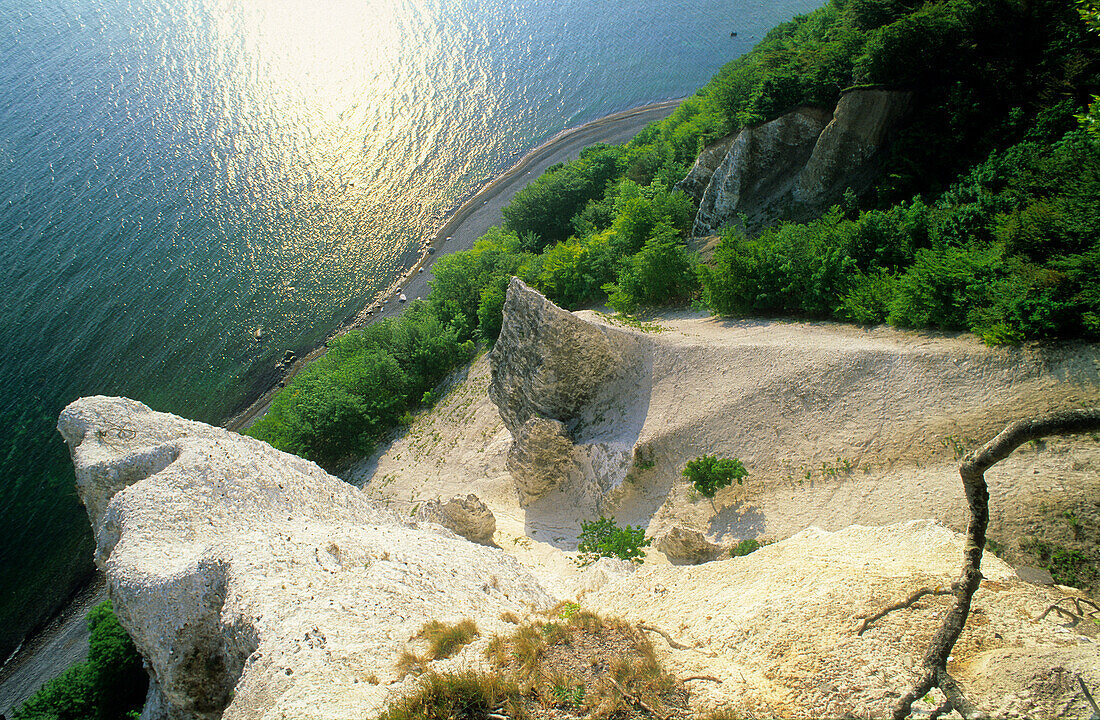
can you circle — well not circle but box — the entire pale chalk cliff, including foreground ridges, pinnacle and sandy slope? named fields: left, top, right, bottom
left=58, top=281, right=1100, bottom=720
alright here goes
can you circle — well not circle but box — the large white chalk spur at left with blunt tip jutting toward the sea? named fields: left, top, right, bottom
left=58, top=397, right=550, bottom=719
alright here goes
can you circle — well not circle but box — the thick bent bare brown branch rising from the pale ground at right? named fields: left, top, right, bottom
left=893, top=408, right=1100, bottom=720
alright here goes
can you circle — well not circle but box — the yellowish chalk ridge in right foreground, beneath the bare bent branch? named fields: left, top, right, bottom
left=583, top=520, right=1100, bottom=718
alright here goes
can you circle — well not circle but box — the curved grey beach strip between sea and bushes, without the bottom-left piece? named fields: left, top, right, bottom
left=221, top=98, right=685, bottom=432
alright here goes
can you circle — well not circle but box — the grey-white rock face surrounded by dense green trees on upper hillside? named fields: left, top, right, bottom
left=678, top=89, right=911, bottom=235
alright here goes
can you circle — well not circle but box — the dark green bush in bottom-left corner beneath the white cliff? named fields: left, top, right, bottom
left=12, top=600, right=149, bottom=720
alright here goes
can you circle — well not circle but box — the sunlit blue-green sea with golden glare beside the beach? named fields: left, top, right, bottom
left=0, top=0, right=820, bottom=658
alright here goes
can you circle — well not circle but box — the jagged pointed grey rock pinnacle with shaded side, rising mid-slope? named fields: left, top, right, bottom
left=488, top=278, right=651, bottom=505
